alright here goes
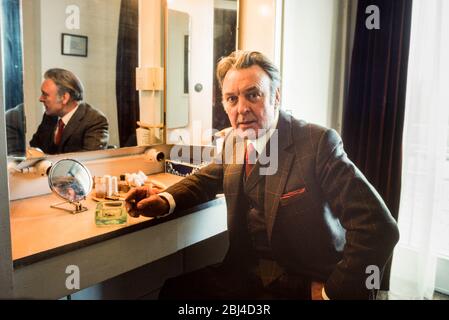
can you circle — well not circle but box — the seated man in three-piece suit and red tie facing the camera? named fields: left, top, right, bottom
left=127, top=51, right=399, bottom=300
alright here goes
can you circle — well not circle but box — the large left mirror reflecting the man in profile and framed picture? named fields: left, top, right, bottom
left=0, top=0, right=164, bottom=156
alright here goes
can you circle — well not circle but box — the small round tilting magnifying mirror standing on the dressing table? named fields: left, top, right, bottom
left=48, top=159, right=92, bottom=213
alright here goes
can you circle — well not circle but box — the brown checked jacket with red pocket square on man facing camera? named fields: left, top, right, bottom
left=166, top=111, right=399, bottom=299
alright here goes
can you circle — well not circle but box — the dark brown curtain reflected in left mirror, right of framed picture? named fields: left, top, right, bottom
left=116, top=0, right=140, bottom=147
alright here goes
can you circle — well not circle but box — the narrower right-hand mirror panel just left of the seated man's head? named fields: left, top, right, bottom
left=166, top=0, right=239, bottom=145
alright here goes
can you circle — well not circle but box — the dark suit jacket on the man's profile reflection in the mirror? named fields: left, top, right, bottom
left=30, top=103, right=109, bottom=154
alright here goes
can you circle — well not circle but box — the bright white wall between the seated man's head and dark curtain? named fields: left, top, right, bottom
left=282, top=0, right=356, bottom=131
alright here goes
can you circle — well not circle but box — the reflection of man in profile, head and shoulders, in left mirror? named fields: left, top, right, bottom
left=30, top=69, right=109, bottom=154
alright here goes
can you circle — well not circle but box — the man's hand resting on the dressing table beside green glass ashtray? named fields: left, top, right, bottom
left=125, top=186, right=170, bottom=217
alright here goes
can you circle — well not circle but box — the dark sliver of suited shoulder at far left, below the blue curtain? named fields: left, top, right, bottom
left=5, top=103, right=26, bottom=156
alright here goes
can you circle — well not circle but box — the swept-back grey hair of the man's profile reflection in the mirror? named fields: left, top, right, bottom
left=44, top=68, right=84, bottom=101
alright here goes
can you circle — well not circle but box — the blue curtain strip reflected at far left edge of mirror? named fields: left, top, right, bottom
left=1, top=0, right=23, bottom=110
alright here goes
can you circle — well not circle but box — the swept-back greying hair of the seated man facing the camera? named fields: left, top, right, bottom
left=217, top=50, right=281, bottom=100
